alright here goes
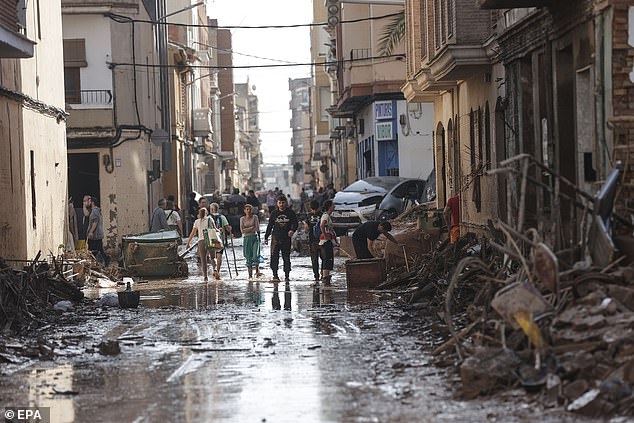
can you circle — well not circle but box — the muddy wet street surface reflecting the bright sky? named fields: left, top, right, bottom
left=0, top=240, right=592, bottom=423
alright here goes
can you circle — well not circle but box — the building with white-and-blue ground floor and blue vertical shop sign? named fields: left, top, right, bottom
left=327, top=0, right=434, bottom=186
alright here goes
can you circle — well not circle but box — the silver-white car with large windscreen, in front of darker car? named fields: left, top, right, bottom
left=331, top=176, right=406, bottom=235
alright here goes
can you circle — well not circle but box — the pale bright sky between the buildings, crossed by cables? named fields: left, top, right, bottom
left=207, top=0, right=312, bottom=163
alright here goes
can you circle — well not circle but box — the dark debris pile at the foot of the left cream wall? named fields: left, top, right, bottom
left=0, top=253, right=83, bottom=333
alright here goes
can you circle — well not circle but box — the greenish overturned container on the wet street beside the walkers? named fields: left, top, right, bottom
left=122, top=230, right=187, bottom=277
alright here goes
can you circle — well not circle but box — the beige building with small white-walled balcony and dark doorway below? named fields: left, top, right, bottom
left=62, top=0, right=162, bottom=254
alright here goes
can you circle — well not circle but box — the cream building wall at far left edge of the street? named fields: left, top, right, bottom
left=0, top=0, right=67, bottom=260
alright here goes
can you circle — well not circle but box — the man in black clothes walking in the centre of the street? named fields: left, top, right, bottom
left=264, top=194, right=297, bottom=282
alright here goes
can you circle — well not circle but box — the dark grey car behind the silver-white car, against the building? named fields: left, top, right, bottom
left=376, top=170, right=436, bottom=220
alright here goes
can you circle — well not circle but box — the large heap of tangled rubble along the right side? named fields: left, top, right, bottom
left=377, top=158, right=634, bottom=416
